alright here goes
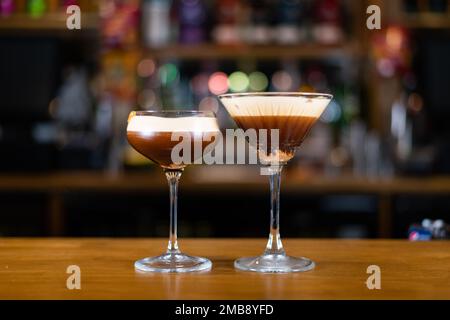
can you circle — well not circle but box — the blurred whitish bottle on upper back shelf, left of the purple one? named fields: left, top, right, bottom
left=141, top=0, right=171, bottom=47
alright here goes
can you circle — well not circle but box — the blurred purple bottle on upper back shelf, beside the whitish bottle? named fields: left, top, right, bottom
left=177, top=0, right=207, bottom=44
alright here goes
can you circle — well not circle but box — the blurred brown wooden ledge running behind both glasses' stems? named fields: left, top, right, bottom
left=0, top=168, right=450, bottom=195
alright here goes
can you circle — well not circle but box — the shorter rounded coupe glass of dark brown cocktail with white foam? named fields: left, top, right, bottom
left=127, top=111, right=220, bottom=272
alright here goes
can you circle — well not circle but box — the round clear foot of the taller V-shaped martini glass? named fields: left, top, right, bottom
left=234, top=254, right=315, bottom=273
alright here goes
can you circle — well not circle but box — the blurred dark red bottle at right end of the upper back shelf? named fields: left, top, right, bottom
left=312, top=0, right=343, bottom=44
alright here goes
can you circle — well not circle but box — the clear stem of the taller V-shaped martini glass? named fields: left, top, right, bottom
left=264, top=165, right=285, bottom=255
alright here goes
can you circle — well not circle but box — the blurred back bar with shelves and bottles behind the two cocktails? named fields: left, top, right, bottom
left=0, top=0, right=450, bottom=238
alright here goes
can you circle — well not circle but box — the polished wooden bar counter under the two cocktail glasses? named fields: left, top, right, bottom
left=0, top=238, right=450, bottom=299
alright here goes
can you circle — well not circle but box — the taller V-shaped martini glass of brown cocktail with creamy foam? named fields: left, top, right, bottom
left=219, top=92, right=333, bottom=272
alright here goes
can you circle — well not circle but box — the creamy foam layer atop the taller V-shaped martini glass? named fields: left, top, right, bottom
left=221, top=95, right=331, bottom=118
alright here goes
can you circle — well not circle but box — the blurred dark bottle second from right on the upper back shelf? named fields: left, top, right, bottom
left=274, top=0, right=305, bottom=44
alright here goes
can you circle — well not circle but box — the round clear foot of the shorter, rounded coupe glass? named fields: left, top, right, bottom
left=134, top=253, right=212, bottom=272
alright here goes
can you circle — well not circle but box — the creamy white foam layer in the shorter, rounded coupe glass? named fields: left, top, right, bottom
left=127, top=115, right=219, bottom=132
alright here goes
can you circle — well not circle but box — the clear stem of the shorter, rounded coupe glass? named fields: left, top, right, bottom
left=164, top=169, right=183, bottom=253
